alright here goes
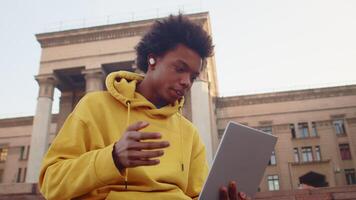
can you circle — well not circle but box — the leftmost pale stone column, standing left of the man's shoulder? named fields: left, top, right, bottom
left=26, top=75, right=56, bottom=183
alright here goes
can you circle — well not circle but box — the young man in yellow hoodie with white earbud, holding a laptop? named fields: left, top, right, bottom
left=39, top=15, right=245, bottom=200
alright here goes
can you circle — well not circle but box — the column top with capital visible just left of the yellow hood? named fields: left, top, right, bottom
left=82, top=69, right=104, bottom=93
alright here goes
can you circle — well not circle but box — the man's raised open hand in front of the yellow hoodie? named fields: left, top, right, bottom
left=112, top=122, right=169, bottom=173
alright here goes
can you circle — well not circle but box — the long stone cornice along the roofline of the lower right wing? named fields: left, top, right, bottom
left=216, top=85, right=356, bottom=108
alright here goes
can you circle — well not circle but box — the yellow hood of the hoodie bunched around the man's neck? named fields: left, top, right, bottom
left=105, top=71, right=184, bottom=117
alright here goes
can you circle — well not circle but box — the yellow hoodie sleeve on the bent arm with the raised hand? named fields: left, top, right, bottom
left=39, top=112, right=123, bottom=200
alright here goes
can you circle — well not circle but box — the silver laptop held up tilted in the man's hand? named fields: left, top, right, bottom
left=199, top=121, right=277, bottom=200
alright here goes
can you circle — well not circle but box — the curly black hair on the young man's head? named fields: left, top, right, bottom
left=135, top=14, right=214, bottom=73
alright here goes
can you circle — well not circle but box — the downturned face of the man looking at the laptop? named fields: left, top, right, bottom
left=147, top=44, right=202, bottom=104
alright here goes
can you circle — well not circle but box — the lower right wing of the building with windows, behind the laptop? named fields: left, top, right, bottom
left=216, top=85, right=356, bottom=191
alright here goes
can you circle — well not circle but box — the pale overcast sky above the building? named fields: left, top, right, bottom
left=0, top=0, right=356, bottom=118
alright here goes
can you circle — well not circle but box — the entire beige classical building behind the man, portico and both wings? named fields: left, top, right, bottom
left=0, top=13, right=356, bottom=199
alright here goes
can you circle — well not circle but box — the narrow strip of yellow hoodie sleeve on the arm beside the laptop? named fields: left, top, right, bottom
left=186, top=131, right=208, bottom=199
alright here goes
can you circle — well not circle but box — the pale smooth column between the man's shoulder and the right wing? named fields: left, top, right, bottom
left=191, top=80, right=213, bottom=165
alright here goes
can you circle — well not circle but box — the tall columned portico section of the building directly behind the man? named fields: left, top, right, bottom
left=26, top=10, right=217, bottom=183
